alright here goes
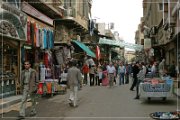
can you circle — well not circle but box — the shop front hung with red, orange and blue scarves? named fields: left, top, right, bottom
left=21, top=2, right=66, bottom=94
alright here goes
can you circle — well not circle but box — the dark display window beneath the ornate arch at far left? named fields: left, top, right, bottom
left=0, top=41, right=19, bottom=98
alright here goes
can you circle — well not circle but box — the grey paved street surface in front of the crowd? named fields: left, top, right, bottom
left=0, top=79, right=180, bottom=120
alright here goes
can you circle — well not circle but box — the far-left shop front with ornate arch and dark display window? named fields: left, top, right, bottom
left=0, top=1, right=27, bottom=98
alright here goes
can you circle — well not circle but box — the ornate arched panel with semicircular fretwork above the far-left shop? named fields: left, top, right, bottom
left=0, top=2, right=27, bottom=40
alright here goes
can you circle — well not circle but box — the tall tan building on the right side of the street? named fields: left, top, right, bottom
left=141, top=0, right=177, bottom=65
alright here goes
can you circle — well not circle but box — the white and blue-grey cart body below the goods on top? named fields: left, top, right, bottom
left=139, top=78, right=173, bottom=100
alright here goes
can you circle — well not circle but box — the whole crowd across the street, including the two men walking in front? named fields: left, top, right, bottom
left=19, top=59, right=179, bottom=118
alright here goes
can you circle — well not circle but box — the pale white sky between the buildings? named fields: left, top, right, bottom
left=91, top=0, right=143, bottom=43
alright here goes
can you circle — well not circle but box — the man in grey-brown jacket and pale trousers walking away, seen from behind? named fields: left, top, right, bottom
left=67, top=61, right=82, bottom=107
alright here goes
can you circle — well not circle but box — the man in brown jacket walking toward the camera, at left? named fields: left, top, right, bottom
left=19, top=61, right=39, bottom=119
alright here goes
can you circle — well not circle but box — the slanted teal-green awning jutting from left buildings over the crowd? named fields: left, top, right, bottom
left=72, top=40, right=96, bottom=58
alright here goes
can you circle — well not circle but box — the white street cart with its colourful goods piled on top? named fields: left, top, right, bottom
left=139, top=77, right=173, bottom=100
